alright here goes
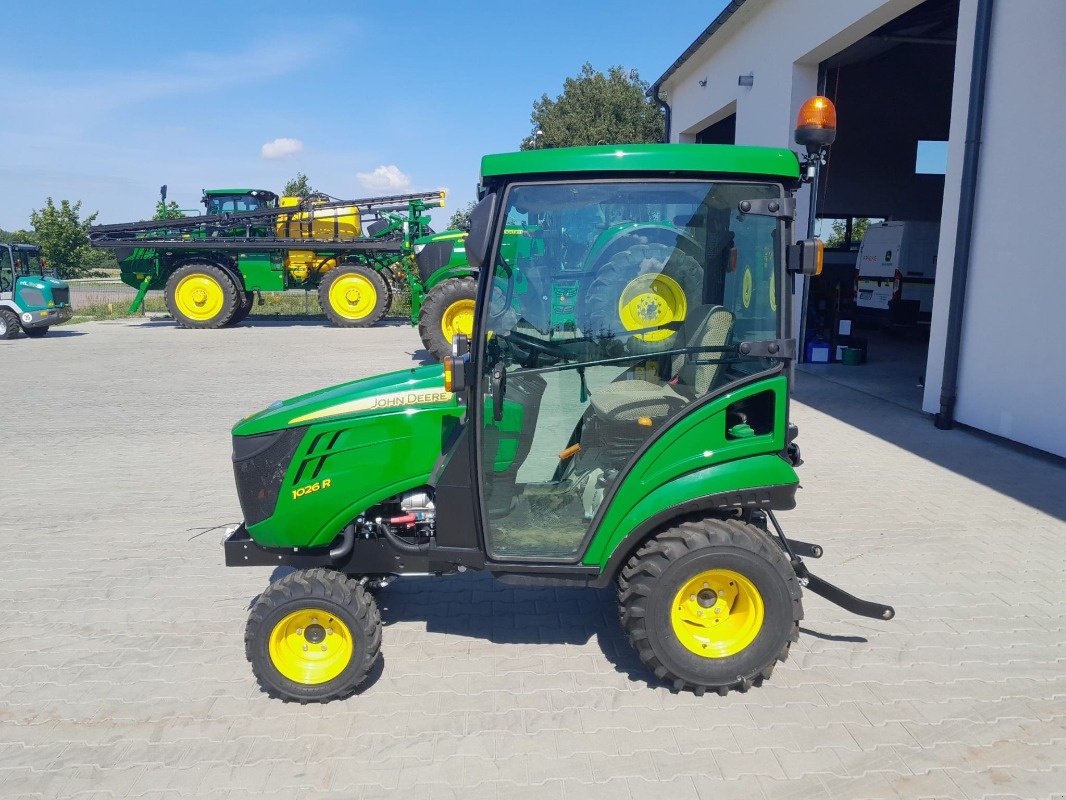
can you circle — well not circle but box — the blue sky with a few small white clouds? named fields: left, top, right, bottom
left=0, top=0, right=725, bottom=229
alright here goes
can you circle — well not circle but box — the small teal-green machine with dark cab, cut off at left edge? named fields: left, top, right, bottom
left=0, top=242, right=74, bottom=339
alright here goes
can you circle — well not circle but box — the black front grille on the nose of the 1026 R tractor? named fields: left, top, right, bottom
left=233, top=426, right=307, bottom=525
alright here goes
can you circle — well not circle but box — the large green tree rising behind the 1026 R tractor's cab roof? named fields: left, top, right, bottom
left=521, top=62, right=663, bottom=150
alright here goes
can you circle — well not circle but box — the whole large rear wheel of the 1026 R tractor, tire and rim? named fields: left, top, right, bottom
left=618, top=519, right=803, bottom=694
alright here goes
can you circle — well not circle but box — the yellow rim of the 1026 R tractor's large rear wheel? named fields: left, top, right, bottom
left=671, top=570, right=765, bottom=658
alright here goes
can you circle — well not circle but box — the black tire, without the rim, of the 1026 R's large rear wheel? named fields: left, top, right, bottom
left=618, top=519, right=803, bottom=694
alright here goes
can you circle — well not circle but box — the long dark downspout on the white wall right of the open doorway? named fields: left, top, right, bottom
left=934, top=0, right=992, bottom=431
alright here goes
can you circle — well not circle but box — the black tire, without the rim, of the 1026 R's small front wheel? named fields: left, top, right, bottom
left=244, top=569, right=382, bottom=703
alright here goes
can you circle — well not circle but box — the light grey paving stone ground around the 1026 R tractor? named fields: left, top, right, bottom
left=0, top=322, right=1066, bottom=800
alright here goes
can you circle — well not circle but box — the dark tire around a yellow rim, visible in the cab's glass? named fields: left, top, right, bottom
left=578, top=243, right=702, bottom=352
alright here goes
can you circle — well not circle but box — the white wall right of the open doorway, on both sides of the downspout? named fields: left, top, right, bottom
left=923, top=0, right=1066, bottom=455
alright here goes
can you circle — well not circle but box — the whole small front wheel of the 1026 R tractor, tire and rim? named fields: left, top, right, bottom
left=244, top=569, right=382, bottom=703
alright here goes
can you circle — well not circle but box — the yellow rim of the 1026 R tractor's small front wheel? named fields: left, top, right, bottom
left=270, top=608, right=354, bottom=686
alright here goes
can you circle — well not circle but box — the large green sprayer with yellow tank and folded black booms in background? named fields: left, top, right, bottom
left=90, top=187, right=445, bottom=329
